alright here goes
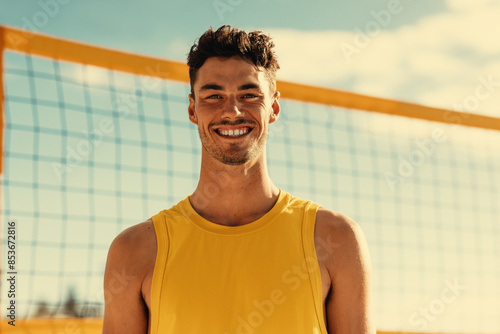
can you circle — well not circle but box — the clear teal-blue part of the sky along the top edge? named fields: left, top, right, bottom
left=0, top=0, right=446, bottom=51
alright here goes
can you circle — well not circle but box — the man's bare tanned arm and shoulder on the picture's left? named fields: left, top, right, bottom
left=102, top=220, right=156, bottom=334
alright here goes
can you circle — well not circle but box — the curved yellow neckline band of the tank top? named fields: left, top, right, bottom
left=179, top=189, right=290, bottom=235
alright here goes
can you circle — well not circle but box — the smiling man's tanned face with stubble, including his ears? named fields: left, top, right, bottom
left=188, top=57, right=280, bottom=165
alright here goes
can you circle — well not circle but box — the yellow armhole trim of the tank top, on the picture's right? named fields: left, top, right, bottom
left=302, top=202, right=328, bottom=334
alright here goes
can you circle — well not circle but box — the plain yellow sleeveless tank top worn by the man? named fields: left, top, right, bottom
left=151, top=190, right=327, bottom=334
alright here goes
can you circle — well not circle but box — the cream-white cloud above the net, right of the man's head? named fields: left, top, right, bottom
left=263, top=0, right=500, bottom=117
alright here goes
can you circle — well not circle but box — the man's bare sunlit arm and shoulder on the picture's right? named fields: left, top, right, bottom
left=317, top=208, right=376, bottom=334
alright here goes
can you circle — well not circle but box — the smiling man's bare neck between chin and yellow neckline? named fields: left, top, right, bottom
left=189, top=154, right=279, bottom=226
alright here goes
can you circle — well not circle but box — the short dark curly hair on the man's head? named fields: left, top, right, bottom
left=187, top=25, right=280, bottom=95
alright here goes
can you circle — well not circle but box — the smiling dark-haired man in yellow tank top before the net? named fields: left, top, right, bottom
left=103, top=26, right=375, bottom=334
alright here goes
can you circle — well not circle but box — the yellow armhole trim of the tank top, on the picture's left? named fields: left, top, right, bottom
left=150, top=211, right=170, bottom=334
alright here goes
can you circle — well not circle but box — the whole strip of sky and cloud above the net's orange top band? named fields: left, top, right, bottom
left=0, top=0, right=500, bottom=117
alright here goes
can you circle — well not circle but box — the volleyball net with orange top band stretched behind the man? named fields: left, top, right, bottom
left=0, top=27, right=500, bottom=333
